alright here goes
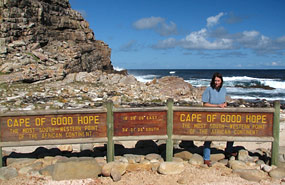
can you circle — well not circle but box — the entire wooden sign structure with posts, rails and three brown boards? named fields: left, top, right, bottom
left=0, top=99, right=280, bottom=166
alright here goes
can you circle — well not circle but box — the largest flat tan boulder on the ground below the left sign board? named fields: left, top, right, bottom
left=52, top=158, right=101, bottom=180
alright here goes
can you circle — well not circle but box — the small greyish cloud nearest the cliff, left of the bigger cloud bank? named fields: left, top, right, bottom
left=133, top=16, right=177, bottom=36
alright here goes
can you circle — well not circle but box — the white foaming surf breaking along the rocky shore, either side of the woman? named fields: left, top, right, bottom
left=130, top=70, right=285, bottom=102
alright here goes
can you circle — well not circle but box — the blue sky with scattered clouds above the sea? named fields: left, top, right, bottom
left=69, top=0, right=285, bottom=69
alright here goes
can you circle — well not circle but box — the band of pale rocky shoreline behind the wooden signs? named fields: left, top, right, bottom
left=0, top=70, right=285, bottom=112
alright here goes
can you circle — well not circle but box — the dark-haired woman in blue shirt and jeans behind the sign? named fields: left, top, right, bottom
left=202, top=73, right=236, bottom=167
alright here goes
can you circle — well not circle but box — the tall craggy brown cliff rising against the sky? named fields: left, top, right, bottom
left=0, top=0, right=114, bottom=82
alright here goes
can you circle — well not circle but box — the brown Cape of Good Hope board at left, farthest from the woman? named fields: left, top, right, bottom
left=0, top=113, right=107, bottom=142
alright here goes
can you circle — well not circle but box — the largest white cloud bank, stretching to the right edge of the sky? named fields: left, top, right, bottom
left=149, top=12, right=285, bottom=57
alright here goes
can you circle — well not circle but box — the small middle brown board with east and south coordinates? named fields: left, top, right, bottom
left=114, top=111, right=167, bottom=136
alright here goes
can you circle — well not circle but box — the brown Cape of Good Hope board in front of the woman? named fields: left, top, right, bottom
left=173, top=111, right=273, bottom=137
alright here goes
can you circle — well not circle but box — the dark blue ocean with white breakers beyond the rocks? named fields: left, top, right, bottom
left=128, top=69, right=285, bottom=104
